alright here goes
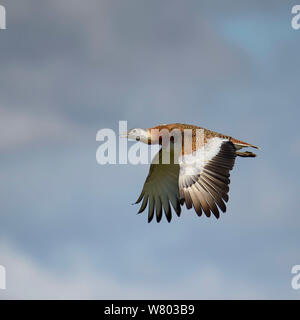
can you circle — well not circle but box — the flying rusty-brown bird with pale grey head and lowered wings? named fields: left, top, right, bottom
left=125, top=123, right=259, bottom=222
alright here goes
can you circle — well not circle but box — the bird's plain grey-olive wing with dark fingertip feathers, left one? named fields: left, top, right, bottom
left=136, top=150, right=181, bottom=222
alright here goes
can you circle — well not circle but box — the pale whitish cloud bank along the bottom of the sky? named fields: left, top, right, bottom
left=0, top=241, right=264, bottom=299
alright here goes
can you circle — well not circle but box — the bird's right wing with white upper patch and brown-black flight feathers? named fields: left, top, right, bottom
left=179, top=138, right=236, bottom=218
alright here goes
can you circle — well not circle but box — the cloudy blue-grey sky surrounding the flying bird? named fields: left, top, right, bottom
left=0, top=0, right=300, bottom=299
